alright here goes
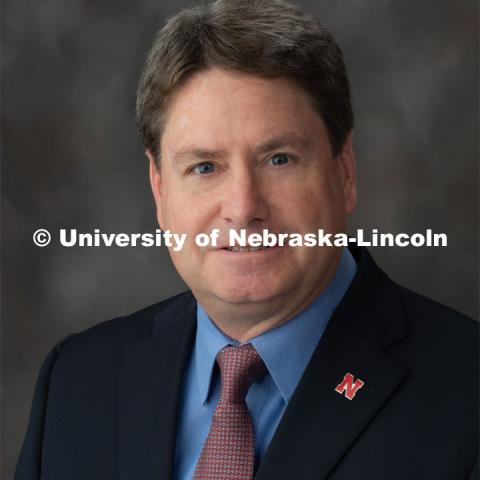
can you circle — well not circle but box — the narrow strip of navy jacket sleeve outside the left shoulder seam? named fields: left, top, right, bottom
left=14, top=337, right=70, bottom=480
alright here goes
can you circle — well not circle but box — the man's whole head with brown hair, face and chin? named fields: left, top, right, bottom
left=138, top=1, right=356, bottom=338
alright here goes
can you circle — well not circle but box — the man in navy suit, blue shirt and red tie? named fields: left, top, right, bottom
left=15, top=0, right=478, bottom=480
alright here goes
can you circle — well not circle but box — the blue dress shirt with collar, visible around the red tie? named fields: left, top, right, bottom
left=174, top=248, right=357, bottom=480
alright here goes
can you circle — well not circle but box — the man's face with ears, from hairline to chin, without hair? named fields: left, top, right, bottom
left=147, top=68, right=355, bottom=316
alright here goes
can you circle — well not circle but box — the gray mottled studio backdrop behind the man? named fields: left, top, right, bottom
left=2, top=0, right=478, bottom=479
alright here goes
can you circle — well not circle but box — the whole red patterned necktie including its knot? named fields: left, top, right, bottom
left=193, top=344, right=267, bottom=480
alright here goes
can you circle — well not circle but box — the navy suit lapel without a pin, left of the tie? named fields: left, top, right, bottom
left=118, top=294, right=196, bottom=480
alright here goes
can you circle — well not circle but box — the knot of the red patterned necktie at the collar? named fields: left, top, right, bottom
left=217, top=343, right=267, bottom=403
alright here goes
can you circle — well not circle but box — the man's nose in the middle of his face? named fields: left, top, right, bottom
left=222, top=166, right=268, bottom=228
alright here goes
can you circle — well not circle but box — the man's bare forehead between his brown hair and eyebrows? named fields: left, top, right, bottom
left=162, top=68, right=326, bottom=150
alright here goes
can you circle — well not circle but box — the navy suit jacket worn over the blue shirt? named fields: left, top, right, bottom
left=15, top=249, right=479, bottom=480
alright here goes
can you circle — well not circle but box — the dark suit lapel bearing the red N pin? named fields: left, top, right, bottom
left=255, top=251, right=408, bottom=480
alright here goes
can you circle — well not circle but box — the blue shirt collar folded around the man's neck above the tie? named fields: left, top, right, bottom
left=194, top=248, right=357, bottom=404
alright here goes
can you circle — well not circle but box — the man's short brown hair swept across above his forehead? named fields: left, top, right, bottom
left=137, top=0, right=353, bottom=159
